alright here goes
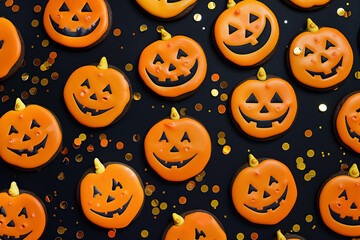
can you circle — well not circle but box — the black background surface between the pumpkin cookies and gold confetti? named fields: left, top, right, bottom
left=0, top=0, right=360, bottom=240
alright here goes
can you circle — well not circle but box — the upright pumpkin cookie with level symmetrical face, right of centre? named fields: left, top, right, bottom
left=230, top=68, right=298, bottom=140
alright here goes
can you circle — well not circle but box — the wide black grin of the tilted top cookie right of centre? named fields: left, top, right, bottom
left=224, top=18, right=271, bottom=55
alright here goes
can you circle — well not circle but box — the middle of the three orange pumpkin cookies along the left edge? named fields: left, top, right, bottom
left=0, top=98, right=62, bottom=170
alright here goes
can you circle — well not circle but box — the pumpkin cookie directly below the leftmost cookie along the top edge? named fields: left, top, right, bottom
left=64, top=57, right=133, bottom=128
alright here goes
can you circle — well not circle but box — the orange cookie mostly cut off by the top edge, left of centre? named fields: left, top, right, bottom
left=136, top=0, right=198, bottom=21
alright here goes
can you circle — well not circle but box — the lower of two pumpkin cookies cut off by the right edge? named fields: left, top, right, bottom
left=319, top=164, right=360, bottom=237
